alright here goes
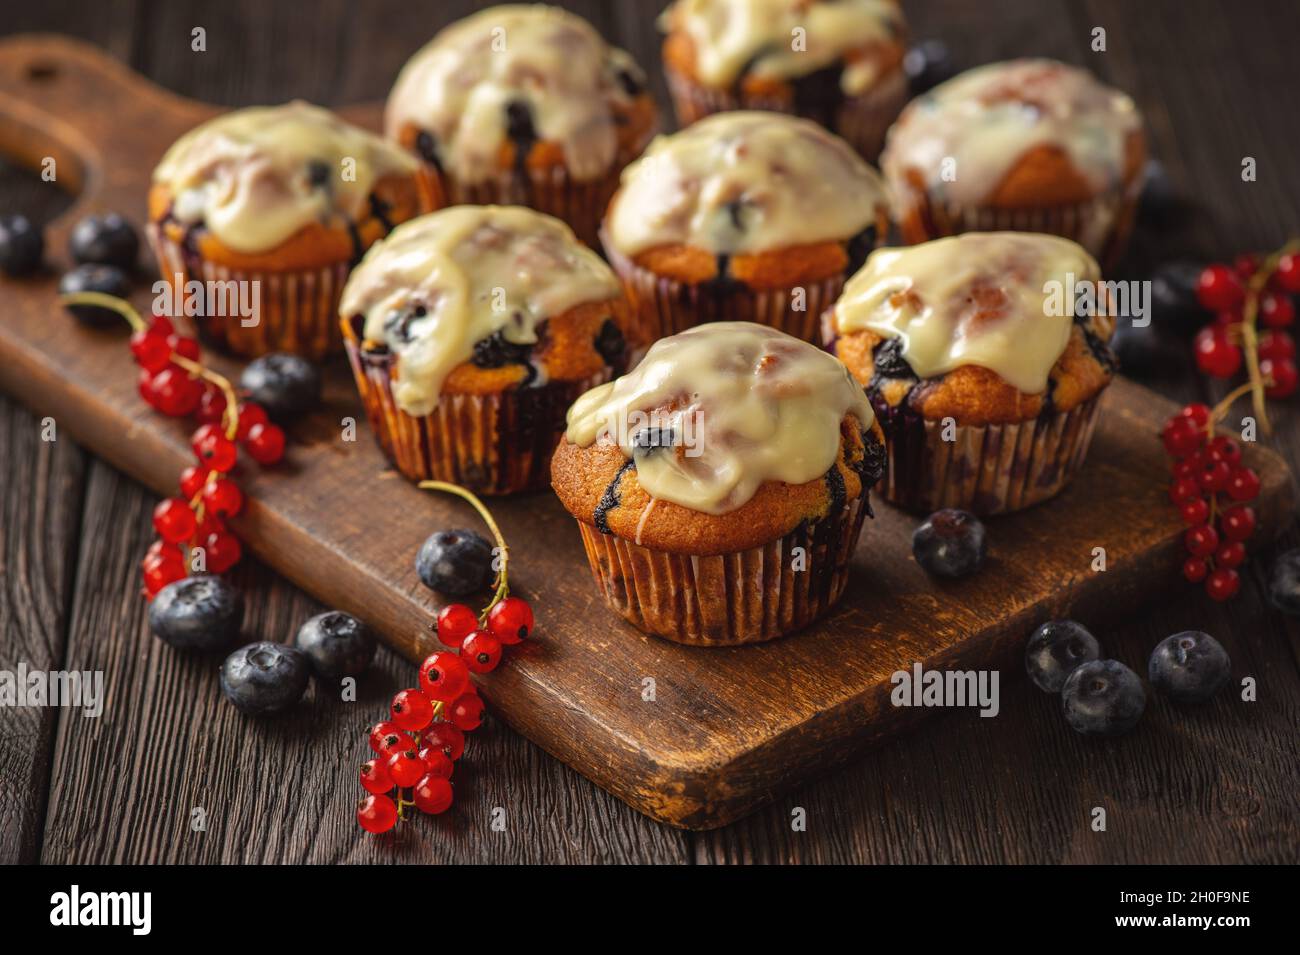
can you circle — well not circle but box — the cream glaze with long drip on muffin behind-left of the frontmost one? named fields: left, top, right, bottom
left=339, top=205, right=620, bottom=416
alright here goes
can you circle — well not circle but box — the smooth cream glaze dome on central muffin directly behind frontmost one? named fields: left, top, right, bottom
left=606, top=110, right=887, bottom=255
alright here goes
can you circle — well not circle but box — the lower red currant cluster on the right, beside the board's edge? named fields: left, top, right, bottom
left=1161, top=400, right=1260, bottom=600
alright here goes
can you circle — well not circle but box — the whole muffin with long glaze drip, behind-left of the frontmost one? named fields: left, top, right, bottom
left=341, top=205, right=631, bottom=494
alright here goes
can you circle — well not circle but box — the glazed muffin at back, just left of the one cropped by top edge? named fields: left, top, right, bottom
left=384, top=4, right=657, bottom=244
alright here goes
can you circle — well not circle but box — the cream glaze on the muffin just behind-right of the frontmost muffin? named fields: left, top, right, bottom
left=835, top=233, right=1101, bottom=394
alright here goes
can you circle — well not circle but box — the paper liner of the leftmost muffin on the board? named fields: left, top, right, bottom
left=146, top=222, right=350, bottom=360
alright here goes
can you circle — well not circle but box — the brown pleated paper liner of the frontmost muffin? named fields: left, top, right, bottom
left=577, top=492, right=867, bottom=647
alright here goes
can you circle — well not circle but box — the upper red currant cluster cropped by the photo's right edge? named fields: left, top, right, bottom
left=1195, top=243, right=1300, bottom=398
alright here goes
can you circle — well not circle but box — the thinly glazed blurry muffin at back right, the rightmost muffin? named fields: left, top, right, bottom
left=880, top=60, right=1147, bottom=265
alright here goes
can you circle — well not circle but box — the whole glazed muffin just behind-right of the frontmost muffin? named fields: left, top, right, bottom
left=828, top=233, right=1115, bottom=515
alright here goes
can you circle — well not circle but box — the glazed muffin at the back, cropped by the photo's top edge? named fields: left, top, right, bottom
left=660, top=0, right=907, bottom=160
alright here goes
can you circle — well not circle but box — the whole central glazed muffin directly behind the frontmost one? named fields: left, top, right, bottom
left=601, top=110, right=889, bottom=342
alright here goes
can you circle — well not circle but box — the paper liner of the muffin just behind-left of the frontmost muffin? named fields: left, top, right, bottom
left=342, top=320, right=612, bottom=494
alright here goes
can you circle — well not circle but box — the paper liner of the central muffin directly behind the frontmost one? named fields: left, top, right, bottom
left=602, top=235, right=845, bottom=344
